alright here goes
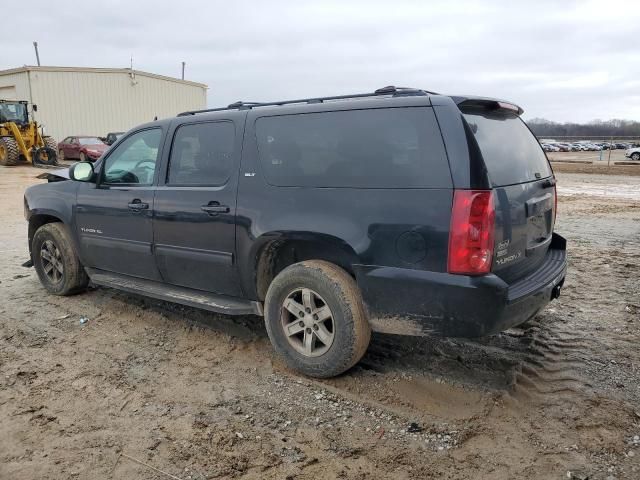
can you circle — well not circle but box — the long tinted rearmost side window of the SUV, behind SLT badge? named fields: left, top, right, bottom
left=256, top=107, right=451, bottom=188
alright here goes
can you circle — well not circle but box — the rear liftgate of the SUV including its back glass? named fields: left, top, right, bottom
left=463, top=108, right=555, bottom=282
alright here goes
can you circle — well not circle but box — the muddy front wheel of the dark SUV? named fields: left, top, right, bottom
left=31, top=223, right=89, bottom=296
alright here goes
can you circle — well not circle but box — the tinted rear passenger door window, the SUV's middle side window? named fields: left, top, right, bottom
left=167, top=122, right=235, bottom=185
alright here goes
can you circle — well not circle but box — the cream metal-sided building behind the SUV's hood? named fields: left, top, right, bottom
left=0, top=66, right=207, bottom=141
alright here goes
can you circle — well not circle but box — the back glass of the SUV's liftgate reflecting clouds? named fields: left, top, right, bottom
left=464, top=111, right=551, bottom=186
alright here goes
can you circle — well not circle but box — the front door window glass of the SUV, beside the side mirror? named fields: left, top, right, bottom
left=103, top=128, right=162, bottom=185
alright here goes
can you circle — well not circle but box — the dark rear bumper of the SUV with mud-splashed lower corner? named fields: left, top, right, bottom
left=355, top=233, right=567, bottom=337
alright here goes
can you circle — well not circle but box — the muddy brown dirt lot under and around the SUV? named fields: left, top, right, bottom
left=0, top=167, right=640, bottom=480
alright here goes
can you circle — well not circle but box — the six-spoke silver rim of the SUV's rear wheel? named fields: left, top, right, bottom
left=280, top=288, right=335, bottom=357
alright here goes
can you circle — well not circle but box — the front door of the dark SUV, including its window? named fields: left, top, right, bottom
left=76, top=128, right=162, bottom=280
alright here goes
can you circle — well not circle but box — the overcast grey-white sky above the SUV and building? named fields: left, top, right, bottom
left=0, top=0, right=640, bottom=122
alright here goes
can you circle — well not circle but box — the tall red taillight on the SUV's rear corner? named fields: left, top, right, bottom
left=448, top=190, right=495, bottom=275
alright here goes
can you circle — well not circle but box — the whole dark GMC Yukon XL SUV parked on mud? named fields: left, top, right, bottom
left=25, top=87, right=566, bottom=377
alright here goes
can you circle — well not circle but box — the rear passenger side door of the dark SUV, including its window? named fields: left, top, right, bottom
left=153, top=117, right=244, bottom=296
